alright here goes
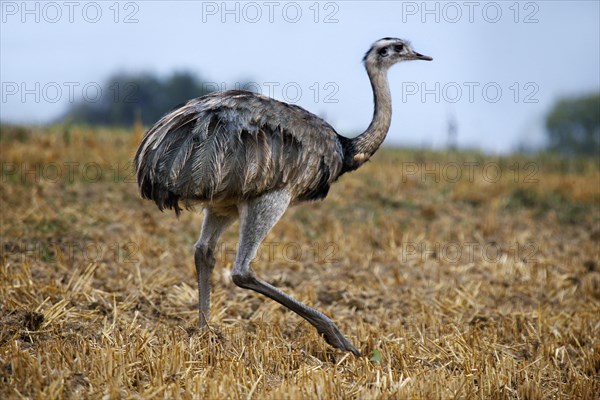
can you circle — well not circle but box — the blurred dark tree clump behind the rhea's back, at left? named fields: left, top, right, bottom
left=66, top=72, right=210, bottom=126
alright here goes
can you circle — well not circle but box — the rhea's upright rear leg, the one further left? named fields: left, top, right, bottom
left=194, top=208, right=237, bottom=328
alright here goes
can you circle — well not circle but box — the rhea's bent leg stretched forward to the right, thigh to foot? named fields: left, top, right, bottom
left=231, top=190, right=360, bottom=356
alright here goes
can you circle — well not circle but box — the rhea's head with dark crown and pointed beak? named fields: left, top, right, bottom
left=363, top=38, right=433, bottom=69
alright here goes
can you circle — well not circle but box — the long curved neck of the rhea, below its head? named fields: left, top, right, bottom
left=344, top=67, right=392, bottom=171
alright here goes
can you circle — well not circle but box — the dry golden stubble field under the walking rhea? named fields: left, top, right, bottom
left=0, top=127, right=600, bottom=399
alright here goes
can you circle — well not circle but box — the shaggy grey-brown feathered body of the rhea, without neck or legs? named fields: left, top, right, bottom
left=135, top=91, right=343, bottom=211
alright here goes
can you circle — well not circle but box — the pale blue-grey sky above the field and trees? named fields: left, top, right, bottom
left=0, top=1, right=600, bottom=153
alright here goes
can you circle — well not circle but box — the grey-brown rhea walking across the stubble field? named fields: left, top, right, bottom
left=135, top=38, right=432, bottom=356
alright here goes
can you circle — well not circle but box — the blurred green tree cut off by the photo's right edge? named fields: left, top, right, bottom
left=546, top=93, right=600, bottom=156
